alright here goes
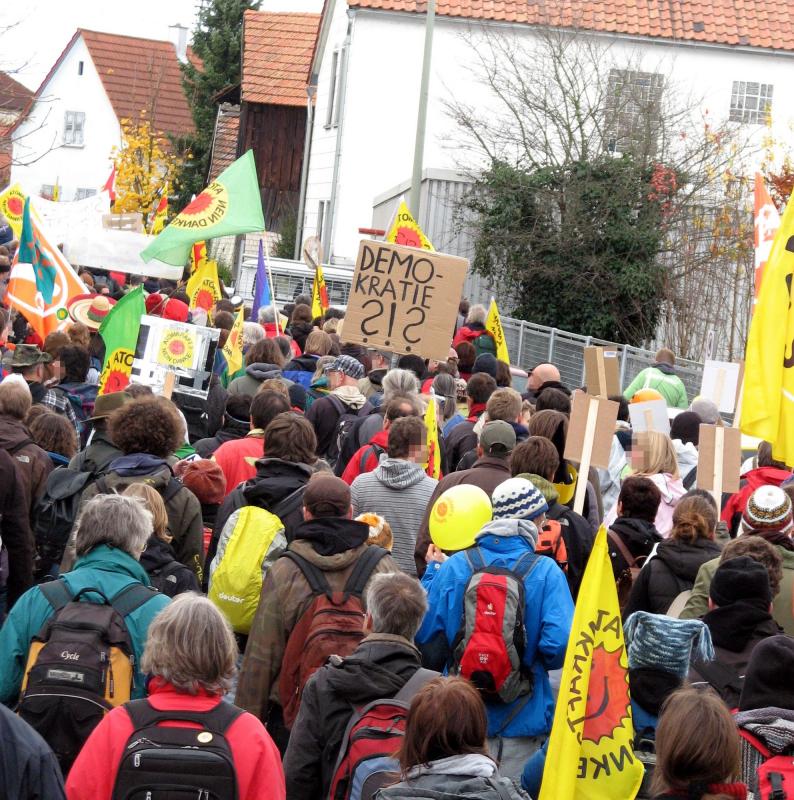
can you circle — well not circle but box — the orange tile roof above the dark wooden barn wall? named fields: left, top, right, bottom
left=242, top=11, right=320, bottom=106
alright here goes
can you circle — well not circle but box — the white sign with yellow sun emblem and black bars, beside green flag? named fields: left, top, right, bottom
left=130, top=316, right=219, bottom=398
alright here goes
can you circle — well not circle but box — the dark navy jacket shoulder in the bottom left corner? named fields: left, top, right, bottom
left=0, top=705, right=66, bottom=800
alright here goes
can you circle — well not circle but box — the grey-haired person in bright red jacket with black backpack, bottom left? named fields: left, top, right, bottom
left=66, top=592, right=286, bottom=800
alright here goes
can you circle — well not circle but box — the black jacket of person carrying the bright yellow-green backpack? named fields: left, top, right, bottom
left=204, top=458, right=312, bottom=591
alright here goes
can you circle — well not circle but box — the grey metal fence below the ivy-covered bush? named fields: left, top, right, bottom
left=502, top=317, right=703, bottom=399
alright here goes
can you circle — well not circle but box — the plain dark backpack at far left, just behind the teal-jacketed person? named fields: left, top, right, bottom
left=31, top=467, right=92, bottom=581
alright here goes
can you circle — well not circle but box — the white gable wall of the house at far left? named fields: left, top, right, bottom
left=11, top=37, right=121, bottom=200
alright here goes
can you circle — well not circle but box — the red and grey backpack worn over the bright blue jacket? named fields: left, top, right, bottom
left=450, top=547, right=540, bottom=703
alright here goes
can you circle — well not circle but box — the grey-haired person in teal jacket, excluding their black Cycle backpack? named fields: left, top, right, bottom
left=0, top=494, right=169, bottom=707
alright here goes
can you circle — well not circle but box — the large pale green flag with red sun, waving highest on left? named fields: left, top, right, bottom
left=141, top=150, right=265, bottom=266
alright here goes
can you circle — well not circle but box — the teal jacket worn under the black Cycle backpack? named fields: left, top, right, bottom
left=0, top=544, right=170, bottom=706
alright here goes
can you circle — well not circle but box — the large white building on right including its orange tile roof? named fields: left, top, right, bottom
left=302, top=0, right=794, bottom=272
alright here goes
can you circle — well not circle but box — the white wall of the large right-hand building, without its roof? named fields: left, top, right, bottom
left=305, top=3, right=794, bottom=263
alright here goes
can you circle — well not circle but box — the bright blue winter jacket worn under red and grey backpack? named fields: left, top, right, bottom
left=416, top=519, right=573, bottom=738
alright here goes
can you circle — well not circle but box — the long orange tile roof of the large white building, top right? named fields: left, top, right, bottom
left=348, top=0, right=794, bottom=50
